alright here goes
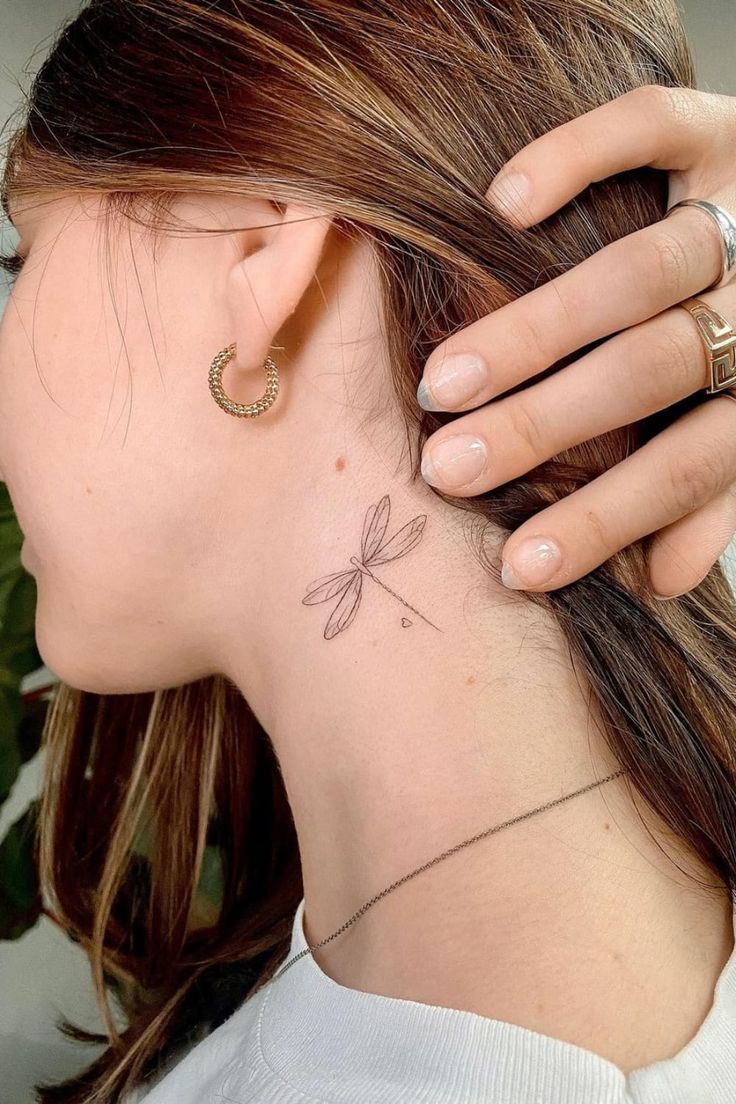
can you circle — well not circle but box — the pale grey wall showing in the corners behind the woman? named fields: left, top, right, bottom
left=0, top=0, right=736, bottom=1104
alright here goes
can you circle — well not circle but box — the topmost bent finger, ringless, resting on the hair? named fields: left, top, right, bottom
left=487, top=85, right=736, bottom=226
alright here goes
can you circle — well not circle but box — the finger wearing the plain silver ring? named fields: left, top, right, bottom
left=417, top=208, right=722, bottom=411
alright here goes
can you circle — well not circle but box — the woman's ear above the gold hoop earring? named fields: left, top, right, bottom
left=223, top=203, right=332, bottom=384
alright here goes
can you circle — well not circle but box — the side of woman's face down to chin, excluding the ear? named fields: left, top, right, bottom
left=0, top=193, right=278, bottom=693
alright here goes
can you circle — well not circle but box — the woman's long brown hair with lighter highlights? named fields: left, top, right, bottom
left=3, top=0, right=736, bottom=1104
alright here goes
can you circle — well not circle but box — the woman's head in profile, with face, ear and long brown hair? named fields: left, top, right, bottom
left=0, top=0, right=736, bottom=1101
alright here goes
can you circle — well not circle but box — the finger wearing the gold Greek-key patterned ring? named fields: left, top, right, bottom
left=422, top=286, right=736, bottom=497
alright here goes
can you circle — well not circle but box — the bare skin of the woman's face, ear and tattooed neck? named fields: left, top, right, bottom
left=0, top=176, right=736, bottom=1071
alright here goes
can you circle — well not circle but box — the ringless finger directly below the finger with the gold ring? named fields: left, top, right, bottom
left=502, top=397, right=736, bottom=591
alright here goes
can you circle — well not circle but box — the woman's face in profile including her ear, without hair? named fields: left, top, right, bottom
left=0, top=184, right=353, bottom=692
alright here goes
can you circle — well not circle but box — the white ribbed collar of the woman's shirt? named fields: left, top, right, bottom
left=260, top=898, right=736, bottom=1104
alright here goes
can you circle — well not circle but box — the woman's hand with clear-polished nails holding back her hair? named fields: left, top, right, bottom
left=417, top=86, right=736, bottom=597
